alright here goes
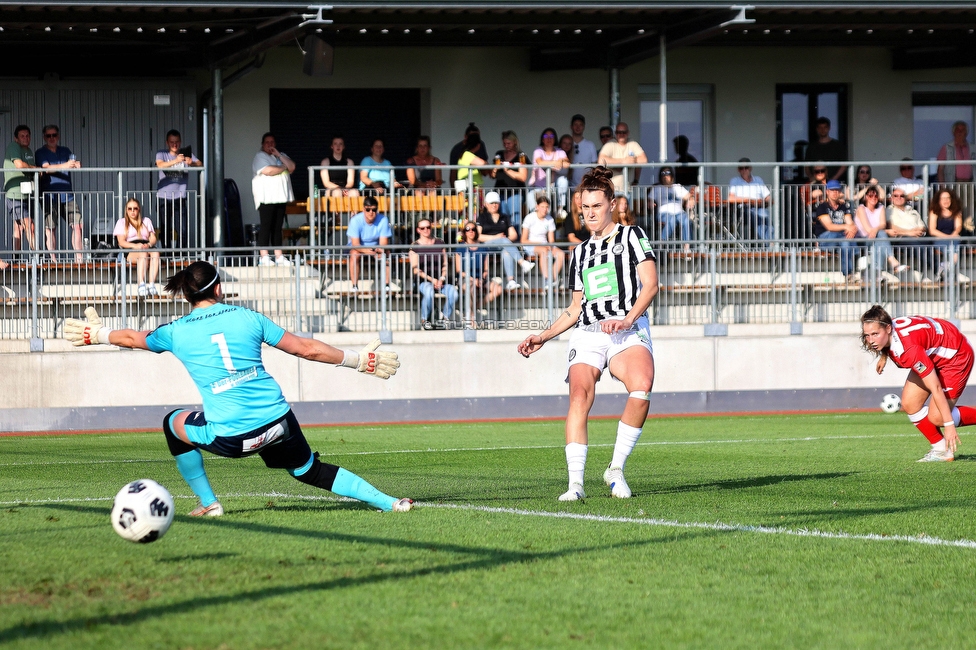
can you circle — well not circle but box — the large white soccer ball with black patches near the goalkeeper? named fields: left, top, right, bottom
left=112, top=478, right=173, bottom=544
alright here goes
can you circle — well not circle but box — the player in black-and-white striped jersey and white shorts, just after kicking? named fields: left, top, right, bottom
left=518, top=167, right=658, bottom=501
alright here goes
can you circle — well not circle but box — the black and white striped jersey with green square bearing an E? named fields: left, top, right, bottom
left=569, top=224, right=657, bottom=325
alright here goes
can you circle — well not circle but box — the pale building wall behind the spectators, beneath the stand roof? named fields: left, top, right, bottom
left=221, top=46, right=976, bottom=222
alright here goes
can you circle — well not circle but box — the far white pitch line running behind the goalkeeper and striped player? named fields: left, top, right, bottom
left=0, top=432, right=928, bottom=467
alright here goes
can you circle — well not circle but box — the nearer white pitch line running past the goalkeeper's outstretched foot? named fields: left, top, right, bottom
left=7, top=492, right=976, bottom=549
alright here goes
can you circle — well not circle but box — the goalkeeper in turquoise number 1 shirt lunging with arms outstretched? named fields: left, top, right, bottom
left=64, top=262, right=413, bottom=517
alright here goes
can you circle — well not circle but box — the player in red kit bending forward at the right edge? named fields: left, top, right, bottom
left=861, top=305, right=976, bottom=462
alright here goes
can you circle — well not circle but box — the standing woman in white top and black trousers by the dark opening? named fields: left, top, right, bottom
left=251, top=133, right=295, bottom=266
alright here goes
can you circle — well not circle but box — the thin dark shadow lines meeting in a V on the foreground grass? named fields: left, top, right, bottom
left=0, top=505, right=728, bottom=644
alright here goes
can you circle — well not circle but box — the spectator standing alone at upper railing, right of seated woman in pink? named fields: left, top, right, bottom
left=156, top=129, right=203, bottom=248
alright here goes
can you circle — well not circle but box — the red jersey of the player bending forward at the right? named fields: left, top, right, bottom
left=888, top=316, right=973, bottom=384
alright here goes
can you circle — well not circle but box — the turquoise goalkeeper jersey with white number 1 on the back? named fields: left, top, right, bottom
left=146, top=303, right=290, bottom=436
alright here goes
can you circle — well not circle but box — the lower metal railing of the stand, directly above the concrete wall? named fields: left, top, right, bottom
left=0, top=238, right=976, bottom=347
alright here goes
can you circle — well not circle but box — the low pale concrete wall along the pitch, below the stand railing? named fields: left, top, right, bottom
left=0, top=321, right=932, bottom=431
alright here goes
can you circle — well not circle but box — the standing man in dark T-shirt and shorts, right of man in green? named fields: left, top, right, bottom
left=34, top=124, right=82, bottom=262
